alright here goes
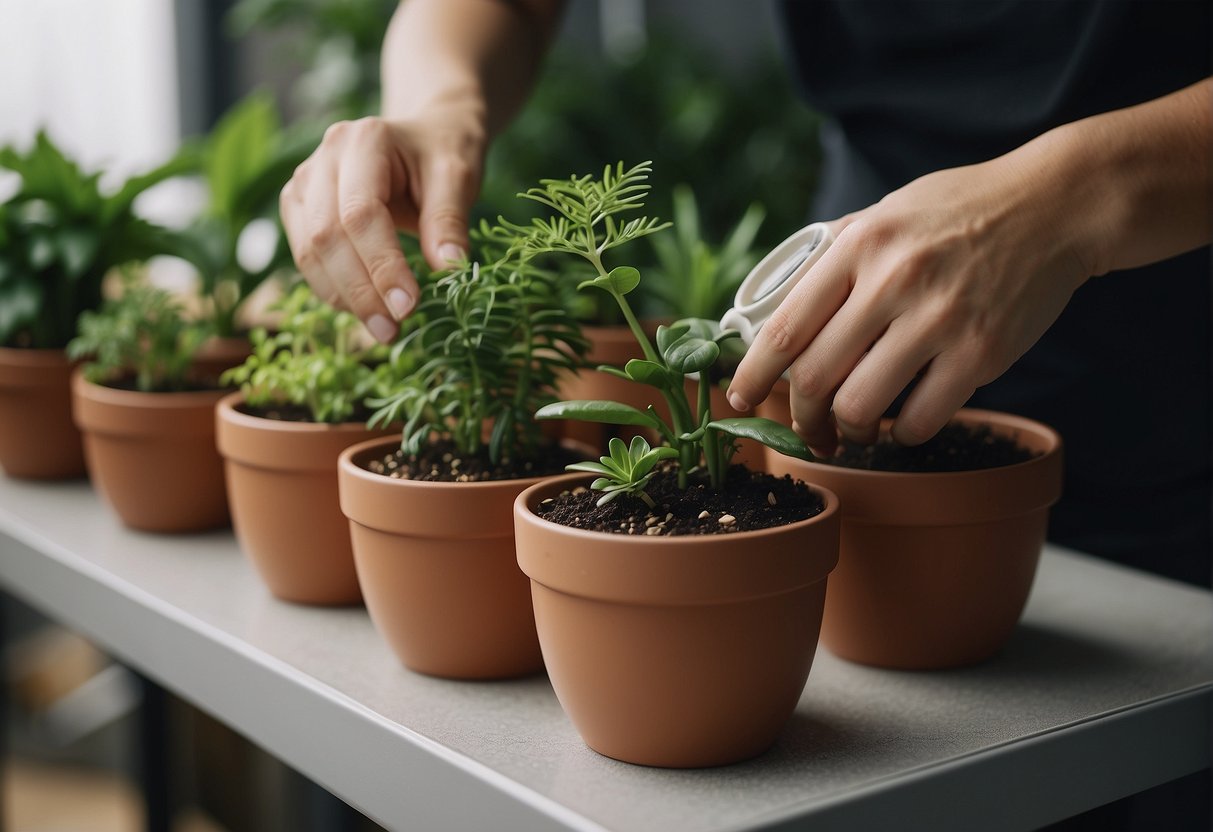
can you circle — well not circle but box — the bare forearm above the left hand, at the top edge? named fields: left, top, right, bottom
left=382, top=0, right=563, bottom=136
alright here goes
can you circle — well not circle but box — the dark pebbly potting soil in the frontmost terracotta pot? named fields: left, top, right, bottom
left=536, top=465, right=825, bottom=535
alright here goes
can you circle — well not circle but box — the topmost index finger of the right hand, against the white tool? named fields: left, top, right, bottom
left=727, top=246, right=850, bottom=412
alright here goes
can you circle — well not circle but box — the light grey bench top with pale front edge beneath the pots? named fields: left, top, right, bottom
left=0, top=477, right=1213, bottom=830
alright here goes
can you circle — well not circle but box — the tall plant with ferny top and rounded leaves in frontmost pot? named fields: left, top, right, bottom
left=511, top=163, right=809, bottom=504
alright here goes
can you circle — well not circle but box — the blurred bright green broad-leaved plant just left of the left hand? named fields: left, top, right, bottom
left=176, top=92, right=315, bottom=336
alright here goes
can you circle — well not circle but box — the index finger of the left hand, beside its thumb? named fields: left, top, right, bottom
left=337, top=119, right=420, bottom=320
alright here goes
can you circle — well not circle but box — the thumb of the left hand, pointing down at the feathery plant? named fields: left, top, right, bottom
left=417, top=158, right=479, bottom=269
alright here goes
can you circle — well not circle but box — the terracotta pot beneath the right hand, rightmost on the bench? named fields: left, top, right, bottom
left=768, top=390, right=1061, bottom=669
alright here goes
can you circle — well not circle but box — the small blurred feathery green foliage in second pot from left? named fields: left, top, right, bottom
left=67, top=280, right=210, bottom=393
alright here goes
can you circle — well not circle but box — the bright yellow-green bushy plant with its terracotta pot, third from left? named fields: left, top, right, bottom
left=216, top=284, right=393, bottom=604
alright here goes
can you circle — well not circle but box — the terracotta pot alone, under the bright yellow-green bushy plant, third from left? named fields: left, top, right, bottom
left=215, top=393, right=399, bottom=604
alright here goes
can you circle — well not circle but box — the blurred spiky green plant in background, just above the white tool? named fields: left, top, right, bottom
left=649, top=184, right=767, bottom=319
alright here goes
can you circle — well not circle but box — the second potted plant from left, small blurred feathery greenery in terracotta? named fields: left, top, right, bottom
left=68, top=283, right=228, bottom=532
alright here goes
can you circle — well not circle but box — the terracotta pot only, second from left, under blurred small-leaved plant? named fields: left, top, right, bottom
left=72, top=371, right=228, bottom=531
